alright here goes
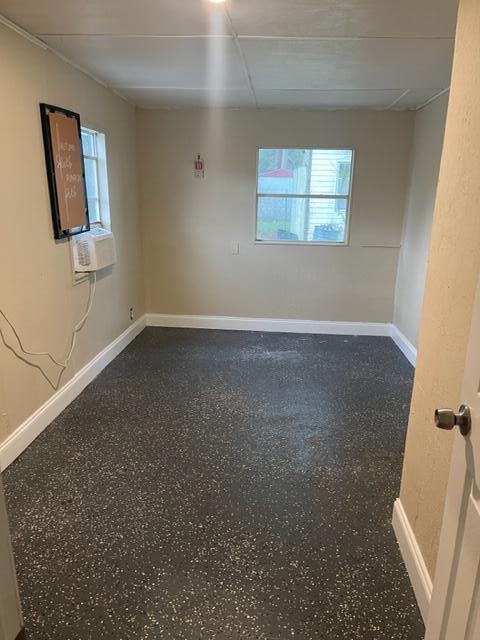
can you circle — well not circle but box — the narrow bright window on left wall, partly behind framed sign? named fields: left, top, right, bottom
left=82, top=127, right=110, bottom=227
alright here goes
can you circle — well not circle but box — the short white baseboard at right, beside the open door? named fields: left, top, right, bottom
left=392, top=498, right=432, bottom=623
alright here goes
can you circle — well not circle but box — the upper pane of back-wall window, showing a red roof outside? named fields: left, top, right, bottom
left=257, top=149, right=353, bottom=195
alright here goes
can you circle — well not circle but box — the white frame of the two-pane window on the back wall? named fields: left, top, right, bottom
left=254, top=146, right=356, bottom=247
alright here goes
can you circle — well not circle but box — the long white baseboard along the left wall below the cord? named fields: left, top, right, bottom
left=0, top=316, right=145, bottom=471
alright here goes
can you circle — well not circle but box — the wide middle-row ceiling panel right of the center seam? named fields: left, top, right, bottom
left=241, top=38, right=453, bottom=90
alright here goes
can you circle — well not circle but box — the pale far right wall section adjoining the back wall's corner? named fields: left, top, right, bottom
left=394, top=94, right=448, bottom=347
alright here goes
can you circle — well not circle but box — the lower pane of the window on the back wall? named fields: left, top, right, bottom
left=257, top=196, right=348, bottom=243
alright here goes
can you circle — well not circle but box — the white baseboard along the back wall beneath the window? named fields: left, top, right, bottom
left=147, top=313, right=391, bottom=336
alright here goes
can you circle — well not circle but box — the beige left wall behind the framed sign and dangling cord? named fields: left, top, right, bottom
left=0, top=26, right=144, bottom=442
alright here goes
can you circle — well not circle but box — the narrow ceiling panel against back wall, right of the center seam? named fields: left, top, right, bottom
left=255, top=90, right=402, bottom=109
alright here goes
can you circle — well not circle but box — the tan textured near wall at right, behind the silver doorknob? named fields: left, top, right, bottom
left=401, top=0, right=480, bottom=575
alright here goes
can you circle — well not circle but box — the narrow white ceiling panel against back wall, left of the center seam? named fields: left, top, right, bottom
left=118, top=89, right=255, bottom=109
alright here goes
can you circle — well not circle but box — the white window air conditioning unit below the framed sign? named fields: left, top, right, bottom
left=72, top=227, right=117, bottom=273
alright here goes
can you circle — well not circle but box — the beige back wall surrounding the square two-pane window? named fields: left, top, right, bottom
left=138, top=110, right=414, bottom=322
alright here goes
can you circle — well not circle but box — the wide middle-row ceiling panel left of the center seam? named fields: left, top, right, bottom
left=40, top=36, right=248, bottom=89
